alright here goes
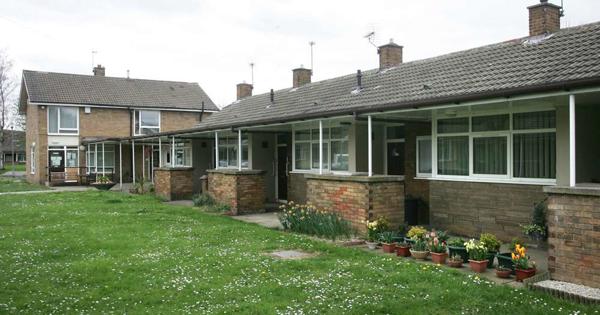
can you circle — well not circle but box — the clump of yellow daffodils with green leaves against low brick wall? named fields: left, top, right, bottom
left=279, top=202, right=352, bottom=240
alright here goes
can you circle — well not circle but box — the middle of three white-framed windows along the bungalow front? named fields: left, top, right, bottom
left=294, top=126, right=348, bottom=171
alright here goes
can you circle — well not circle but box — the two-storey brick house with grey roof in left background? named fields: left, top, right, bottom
left=19, top=65, right=219, bottom=185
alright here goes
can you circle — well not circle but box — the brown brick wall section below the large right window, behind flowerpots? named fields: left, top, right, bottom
left=430, top=180, right=546, bottom=241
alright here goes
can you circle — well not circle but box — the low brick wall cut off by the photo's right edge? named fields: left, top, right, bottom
left=544, top=187, right=600, bottom=288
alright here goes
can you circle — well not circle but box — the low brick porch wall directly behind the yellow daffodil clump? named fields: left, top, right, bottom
left=305, top=174, right=404, bottom=232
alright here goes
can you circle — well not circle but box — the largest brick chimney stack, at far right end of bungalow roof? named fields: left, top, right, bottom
left=527, top=0, right=562, bottom=36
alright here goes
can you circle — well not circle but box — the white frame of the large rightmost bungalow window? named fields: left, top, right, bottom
left=426, top=106, right=556, bottom=185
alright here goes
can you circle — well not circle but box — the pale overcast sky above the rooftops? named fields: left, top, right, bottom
left=0, top=0, right=600, bottom=107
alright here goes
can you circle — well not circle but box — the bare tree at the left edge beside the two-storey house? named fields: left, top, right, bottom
left=0, top=51, right=17, bottom=169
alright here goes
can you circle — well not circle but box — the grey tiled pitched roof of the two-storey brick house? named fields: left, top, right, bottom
left=23, top=70, right=219, bottom=111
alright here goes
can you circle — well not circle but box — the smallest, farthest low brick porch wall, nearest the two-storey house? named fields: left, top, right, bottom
left=154, top=167, right=194, bottom=200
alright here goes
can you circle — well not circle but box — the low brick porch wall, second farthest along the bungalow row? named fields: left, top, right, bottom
left=207, top=169, right=266, bottom=215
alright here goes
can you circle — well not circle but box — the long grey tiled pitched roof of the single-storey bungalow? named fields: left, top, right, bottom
left=197, top=23, right=600, bottom=130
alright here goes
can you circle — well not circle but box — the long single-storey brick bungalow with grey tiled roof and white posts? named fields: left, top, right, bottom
left=82, top=0, right=600, bottom=285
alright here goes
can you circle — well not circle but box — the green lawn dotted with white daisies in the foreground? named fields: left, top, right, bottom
left=0, top=191, right=595, bottom=314
